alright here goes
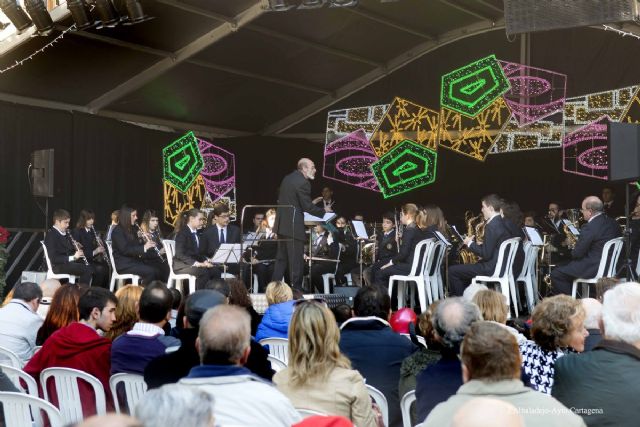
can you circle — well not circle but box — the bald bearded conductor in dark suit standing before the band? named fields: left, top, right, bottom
left=272, top=158, right=331, bottom=289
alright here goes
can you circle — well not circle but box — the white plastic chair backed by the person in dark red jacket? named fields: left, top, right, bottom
left=40, top=368, right=107, bottom=424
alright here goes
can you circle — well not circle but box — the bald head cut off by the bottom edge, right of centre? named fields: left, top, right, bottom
left=451, top=397, right=524, bottom=427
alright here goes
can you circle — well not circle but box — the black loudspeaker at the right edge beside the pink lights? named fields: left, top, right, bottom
left=607, top=122, right=640, bottom=181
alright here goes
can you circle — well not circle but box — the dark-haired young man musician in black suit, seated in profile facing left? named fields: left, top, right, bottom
left=449, top=194, right=510, bottom=296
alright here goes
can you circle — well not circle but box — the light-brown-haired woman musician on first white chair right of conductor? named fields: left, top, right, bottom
left=374, top=203, right=434, bottom=287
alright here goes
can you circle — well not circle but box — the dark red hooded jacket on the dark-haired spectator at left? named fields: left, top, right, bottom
left=24, top=322, right=113, bottom=418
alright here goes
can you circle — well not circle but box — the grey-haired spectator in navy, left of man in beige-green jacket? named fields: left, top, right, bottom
left=416, top=298, right=481, bottom=420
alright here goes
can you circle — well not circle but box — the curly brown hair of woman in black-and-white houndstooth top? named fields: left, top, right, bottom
left=531, top=295, right=586, bottom=351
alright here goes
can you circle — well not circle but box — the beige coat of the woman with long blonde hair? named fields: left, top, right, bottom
left=273, top=368, right=377, bottom=427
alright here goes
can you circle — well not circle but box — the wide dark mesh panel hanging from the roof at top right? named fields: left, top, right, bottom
left=504, top=0, right=638, bottom=35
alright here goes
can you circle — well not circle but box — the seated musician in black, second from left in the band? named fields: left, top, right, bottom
left=71, top=209, right=109, bottom=288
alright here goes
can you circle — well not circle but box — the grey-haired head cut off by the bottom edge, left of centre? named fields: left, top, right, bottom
left=135, top=384, right=215, bottom=427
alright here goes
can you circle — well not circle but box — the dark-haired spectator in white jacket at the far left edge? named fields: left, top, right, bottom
left=0, top=282, right=43, bottom=363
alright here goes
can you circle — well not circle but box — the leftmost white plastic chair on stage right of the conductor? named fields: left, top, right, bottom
left=389, top=239, right=435, bottom=311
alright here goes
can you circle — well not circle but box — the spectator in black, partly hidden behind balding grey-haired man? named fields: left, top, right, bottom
left=144, top=289, right=273, bottom=389
